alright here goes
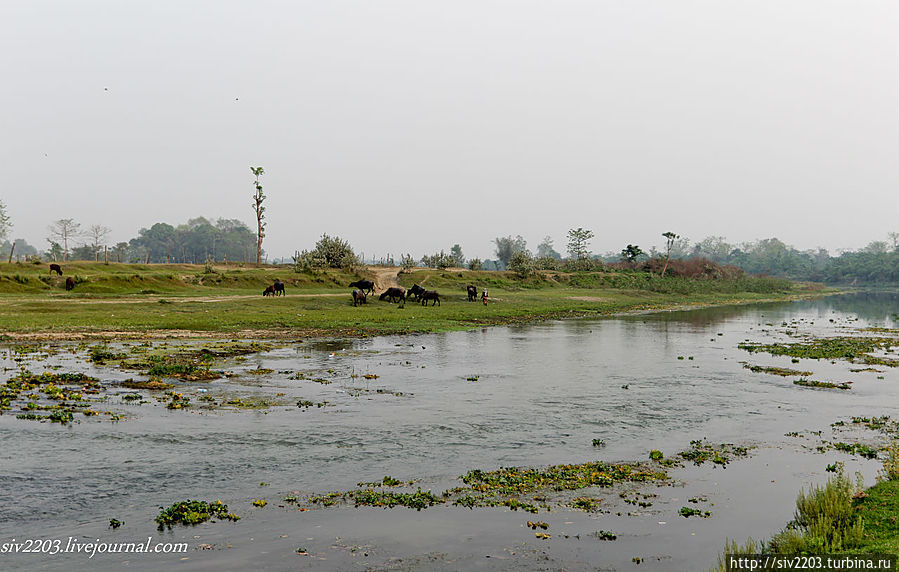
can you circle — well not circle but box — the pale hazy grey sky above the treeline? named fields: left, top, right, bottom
left=0, top=0, right=899, bottom=259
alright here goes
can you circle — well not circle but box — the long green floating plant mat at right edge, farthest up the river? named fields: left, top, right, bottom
left=737, top=337, right=899, bottom=367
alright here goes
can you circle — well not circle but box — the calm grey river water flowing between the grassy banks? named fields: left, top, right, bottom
left=0, top=293, right=899, bottom=570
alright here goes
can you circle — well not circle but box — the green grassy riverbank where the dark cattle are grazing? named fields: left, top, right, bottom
left=0, top=262, right=828, bottom=338
